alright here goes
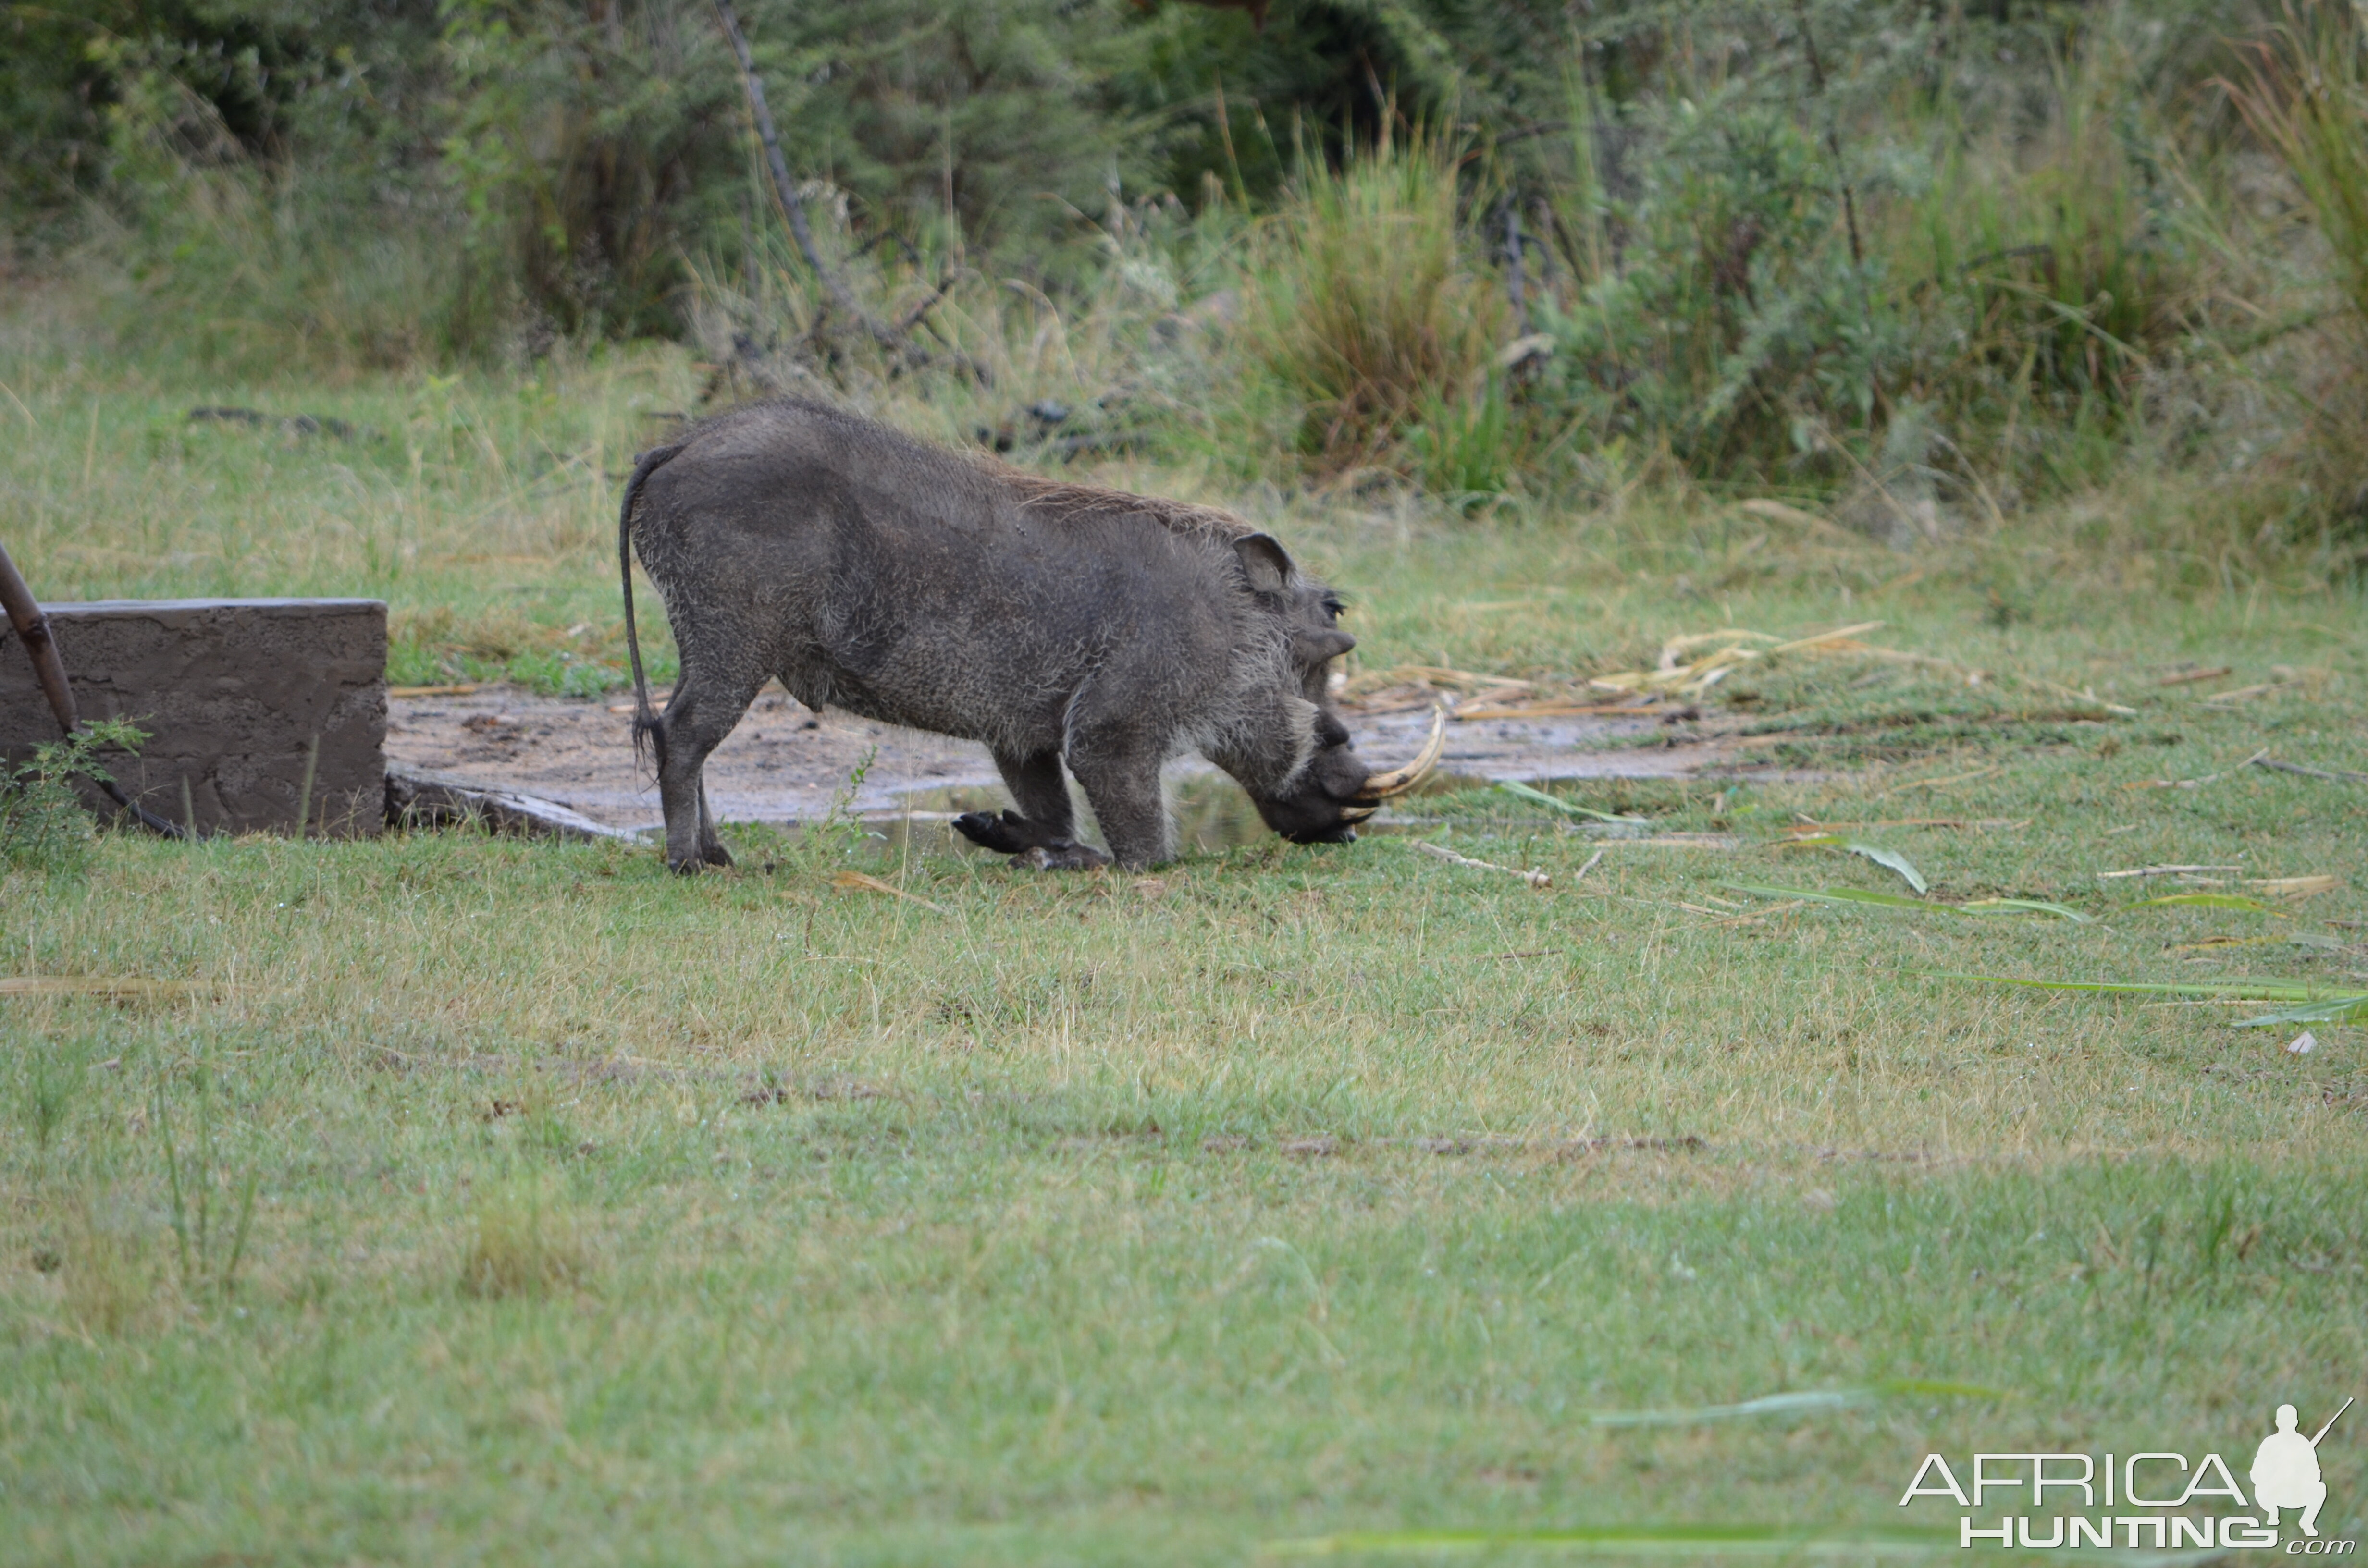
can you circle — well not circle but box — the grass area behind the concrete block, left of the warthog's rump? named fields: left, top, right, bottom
left=0, top=294, right=699, bottom=692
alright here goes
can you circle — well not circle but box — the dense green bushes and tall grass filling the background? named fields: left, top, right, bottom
left=13, top=0, right=2368, bottom=540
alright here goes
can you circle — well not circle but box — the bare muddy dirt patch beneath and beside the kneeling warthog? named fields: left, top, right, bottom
left=386, top=687, right=1728, bottom=829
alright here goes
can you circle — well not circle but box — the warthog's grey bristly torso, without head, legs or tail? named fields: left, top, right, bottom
left=635, top=403, right=1265, bottom=751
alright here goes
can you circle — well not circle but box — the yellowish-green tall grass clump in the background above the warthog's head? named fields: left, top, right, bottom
left=1243, top=133, right=1508, bottom=476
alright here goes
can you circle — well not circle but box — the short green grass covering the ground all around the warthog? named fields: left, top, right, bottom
left=0, top=303, right=2368, bottom=1563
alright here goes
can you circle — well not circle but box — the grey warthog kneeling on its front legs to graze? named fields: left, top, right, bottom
left=616, top=400, right=1444, bottom=871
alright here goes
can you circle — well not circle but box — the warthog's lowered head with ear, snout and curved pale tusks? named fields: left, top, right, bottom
left=1233, top=533, right=1447, bottom=843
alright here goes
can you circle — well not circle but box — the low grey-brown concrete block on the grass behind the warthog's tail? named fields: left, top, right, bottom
left=0, top=599, right=386, bottom=836
